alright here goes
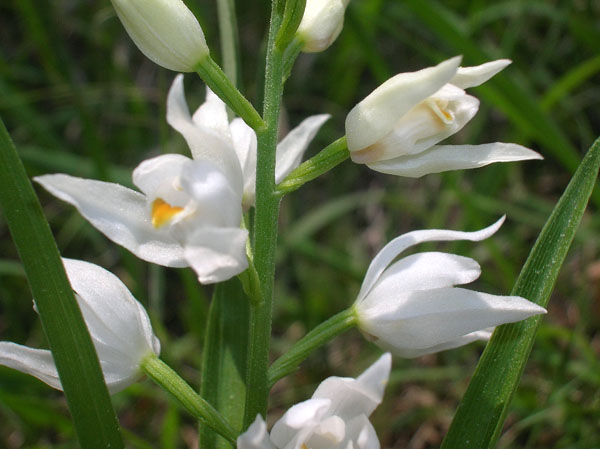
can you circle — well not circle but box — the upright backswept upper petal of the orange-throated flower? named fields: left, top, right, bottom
left=167, top=76, right=243, bottom=191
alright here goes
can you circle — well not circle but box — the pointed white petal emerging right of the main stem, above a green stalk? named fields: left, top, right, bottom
left=275, top=114, right=330, bottom=183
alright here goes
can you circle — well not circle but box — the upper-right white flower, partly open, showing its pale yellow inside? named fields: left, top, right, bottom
left=346, top=56, right=542, bottom=178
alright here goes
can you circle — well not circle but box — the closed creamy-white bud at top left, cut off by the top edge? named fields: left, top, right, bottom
left=112, top=0, right=209, bottom=72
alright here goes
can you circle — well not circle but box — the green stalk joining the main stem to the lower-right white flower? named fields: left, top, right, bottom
left=268, top=308, right=357, bottom=386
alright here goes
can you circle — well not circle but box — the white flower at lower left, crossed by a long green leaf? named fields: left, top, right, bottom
left=0, top=259, right=160, bottom=393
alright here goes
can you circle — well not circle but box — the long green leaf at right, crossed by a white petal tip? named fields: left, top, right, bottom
left=441, top=138, right=600, bottom=449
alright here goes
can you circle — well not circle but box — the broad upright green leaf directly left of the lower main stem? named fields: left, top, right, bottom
left=200, top=278, right=250, bottom=449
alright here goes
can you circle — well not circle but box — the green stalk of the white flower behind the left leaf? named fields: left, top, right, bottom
left=140, top=354, right=237, bottom=444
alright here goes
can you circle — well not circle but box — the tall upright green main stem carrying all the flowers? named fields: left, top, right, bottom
left=244, top=0, right=283, bottom=428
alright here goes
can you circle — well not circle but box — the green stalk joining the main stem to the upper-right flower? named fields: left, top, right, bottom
left=277, top=136, right=350, bottom=195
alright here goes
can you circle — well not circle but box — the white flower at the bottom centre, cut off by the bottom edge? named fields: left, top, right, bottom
left=237, top=353, right=392, bottom=449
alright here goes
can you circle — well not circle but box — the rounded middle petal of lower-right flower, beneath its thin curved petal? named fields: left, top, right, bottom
left=360, top=252, right=481, bottom=309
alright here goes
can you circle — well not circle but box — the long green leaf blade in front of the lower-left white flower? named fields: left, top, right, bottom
left=0, top=115, right=123, bottom=449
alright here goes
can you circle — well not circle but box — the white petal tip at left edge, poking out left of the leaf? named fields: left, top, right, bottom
left=0, top=341, right=62, bottom=390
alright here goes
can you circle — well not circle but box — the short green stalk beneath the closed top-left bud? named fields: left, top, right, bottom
left=196, top=56, right=266, bottom=132
